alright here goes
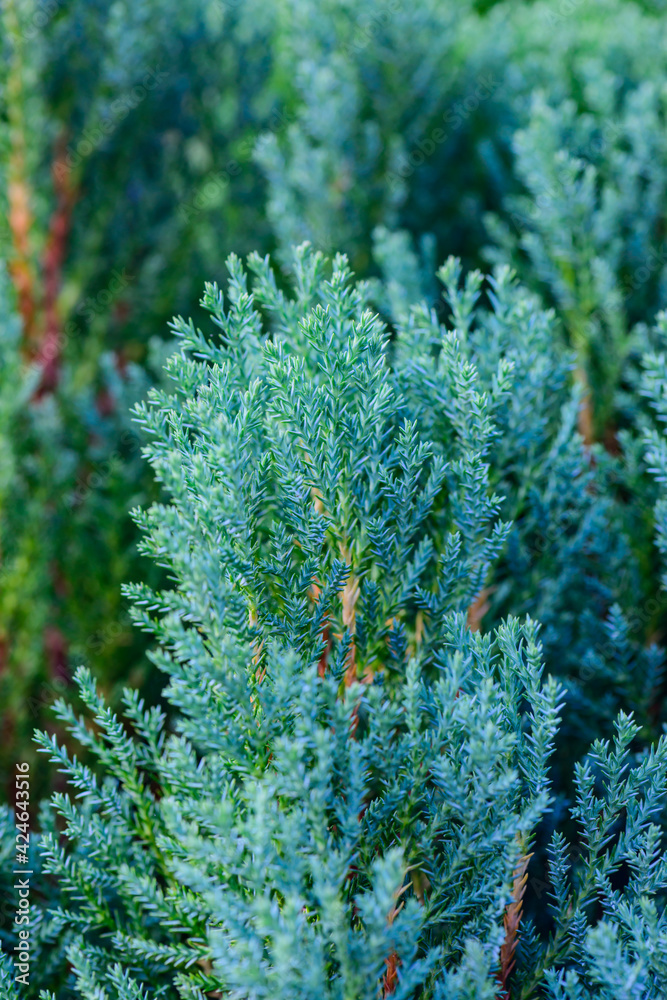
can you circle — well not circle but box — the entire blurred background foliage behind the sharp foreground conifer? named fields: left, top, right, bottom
left=0, top=0, right=667, bottom=794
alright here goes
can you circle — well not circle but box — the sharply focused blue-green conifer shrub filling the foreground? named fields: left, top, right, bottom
left=5, top=245, right=667, bottom=1000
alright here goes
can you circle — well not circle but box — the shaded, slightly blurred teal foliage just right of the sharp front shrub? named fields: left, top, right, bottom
left=379, top=234, right=664, bottom=756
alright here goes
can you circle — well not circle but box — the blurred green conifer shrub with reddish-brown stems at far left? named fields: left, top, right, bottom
left=0, top=0, right=289, bottom=801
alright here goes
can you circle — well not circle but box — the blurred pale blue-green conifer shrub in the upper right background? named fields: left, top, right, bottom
left=256, top=0, right=667, bottom=440
